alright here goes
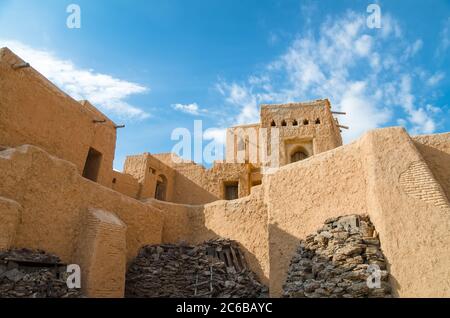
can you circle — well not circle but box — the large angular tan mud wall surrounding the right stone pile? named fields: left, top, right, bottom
left=265, top=128, right=450, bottom=297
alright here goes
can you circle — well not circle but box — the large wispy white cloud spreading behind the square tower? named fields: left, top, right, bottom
left=219, top=12, right=441, bottom=142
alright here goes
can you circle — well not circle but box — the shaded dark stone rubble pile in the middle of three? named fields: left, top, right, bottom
left=126, top=240, right=267, bottom=298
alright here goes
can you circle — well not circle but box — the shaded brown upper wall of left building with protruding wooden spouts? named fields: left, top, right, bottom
left=0, top=48, right=116, bottom=186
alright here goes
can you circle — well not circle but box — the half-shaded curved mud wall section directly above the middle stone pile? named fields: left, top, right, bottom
left=147, top=187, right=269, bottom=284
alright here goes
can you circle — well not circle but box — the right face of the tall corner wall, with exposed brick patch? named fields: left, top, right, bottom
left=362, top=128, right=450, bottom=297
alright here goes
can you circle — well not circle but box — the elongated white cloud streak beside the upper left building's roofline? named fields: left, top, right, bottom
left=0, top=39, right=150, bottom=120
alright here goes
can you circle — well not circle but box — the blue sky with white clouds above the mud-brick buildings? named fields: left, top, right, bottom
left=0, top=0, right=450, bottom=169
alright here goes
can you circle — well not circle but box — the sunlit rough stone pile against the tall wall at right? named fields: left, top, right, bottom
left=283, top=215, right=391, bottom=298
